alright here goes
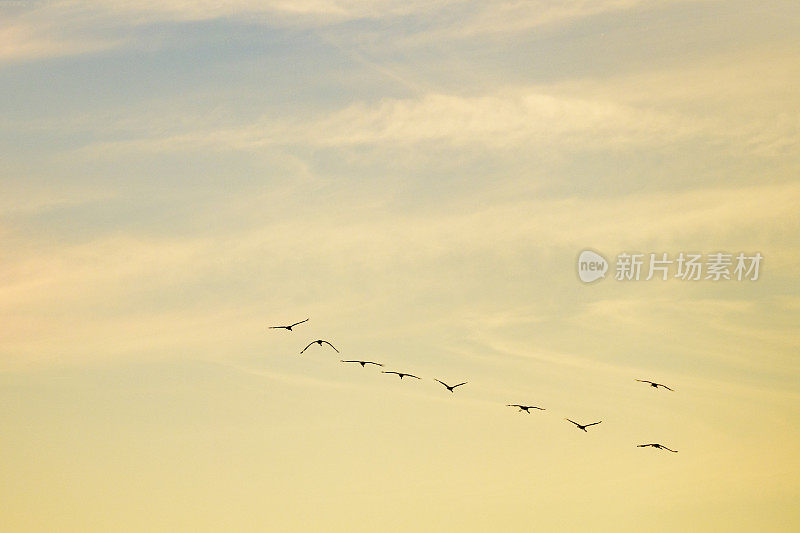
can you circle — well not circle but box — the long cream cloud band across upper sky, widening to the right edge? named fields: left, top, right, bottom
left=54, top=43, right=800, bottom=157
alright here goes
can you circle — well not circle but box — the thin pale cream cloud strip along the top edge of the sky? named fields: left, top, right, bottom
left=0, top=0, right=712, bottom=65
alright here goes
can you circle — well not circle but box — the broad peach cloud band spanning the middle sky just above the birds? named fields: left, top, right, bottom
left=0, top=177, right=800, bottom=368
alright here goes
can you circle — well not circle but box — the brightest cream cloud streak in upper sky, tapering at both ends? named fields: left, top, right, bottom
left=67, top=89, right=708, bottom=156
